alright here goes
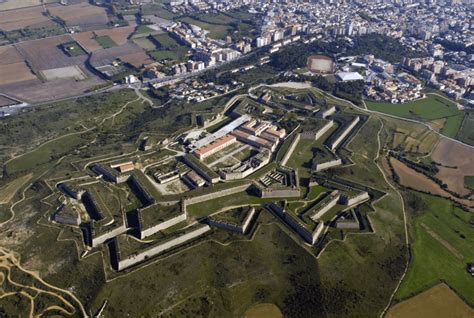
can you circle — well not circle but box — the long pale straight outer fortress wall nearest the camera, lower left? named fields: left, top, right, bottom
left=118, top=225, right=211, bottom=271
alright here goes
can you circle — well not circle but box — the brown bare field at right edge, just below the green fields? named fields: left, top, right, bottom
left=431, top=138, right=474, bottom=195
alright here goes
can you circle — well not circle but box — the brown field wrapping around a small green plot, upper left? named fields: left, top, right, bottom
left=73, top=26, right=135, bottom=52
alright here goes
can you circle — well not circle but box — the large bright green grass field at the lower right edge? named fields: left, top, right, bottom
left=396, top=193, right=474, bottom=306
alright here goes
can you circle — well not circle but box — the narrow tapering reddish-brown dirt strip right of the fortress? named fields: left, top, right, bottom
left=390, top=158, right=473, bottom=207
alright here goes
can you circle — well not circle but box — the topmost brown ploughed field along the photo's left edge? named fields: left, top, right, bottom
left=0, top=6, right=54, bottom=31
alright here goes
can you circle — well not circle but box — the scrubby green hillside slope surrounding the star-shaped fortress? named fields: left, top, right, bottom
left=0, top=84, right=406, bottom=317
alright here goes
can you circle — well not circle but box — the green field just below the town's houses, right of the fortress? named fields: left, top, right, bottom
left=366, top=94, right=464, bottom=138
